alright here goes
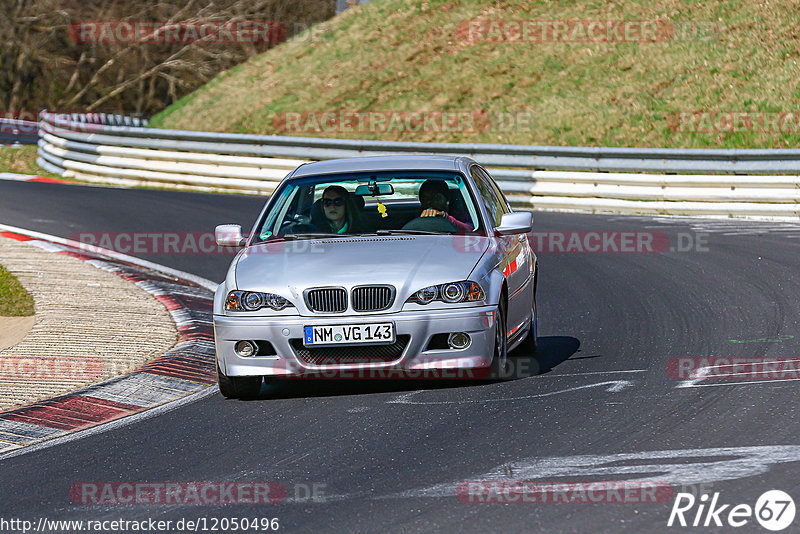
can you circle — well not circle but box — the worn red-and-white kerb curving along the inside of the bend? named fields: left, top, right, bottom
left=0, top=231, right=216, bottom=459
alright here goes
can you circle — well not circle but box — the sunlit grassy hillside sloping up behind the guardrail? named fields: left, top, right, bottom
left=151, top=0, right=800, bottom=148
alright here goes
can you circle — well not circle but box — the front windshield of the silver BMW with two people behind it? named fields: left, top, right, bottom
left=255, top=171, right=482, bottom=242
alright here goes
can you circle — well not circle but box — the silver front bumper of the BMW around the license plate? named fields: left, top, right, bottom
left=214, top=306, right=497, bottom=378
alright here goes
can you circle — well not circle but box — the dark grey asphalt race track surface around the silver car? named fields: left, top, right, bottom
left=0, top=182, right=800, bottom=533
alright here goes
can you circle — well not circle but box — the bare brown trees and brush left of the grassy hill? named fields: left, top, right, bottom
left=0, top=0, right=335, bottom=115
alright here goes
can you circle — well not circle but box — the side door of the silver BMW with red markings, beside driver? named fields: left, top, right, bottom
left=472, top=165, right=533, bottom=337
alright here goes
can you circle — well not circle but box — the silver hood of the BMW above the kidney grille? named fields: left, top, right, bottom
left=235, top=235, right=490, bottom=308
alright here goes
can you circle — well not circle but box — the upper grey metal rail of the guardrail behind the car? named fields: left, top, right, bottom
left=39, top=115, right=800, bottom=174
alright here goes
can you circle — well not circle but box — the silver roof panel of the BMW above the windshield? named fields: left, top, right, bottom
left=292, top=155, right=472, bottom=178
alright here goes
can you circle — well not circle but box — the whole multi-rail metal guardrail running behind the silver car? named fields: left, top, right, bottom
left=34, top=113, right=800, bottom=218
